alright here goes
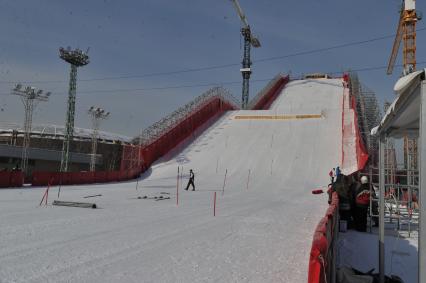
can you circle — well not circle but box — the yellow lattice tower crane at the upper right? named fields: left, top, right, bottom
left=387, top=0, right=420, bottom=75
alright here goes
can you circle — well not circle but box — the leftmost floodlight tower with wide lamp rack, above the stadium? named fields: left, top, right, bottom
left=12, top=84, right=50, bottom=173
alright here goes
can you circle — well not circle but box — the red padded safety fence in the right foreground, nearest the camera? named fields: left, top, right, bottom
left=308, top=192, right=339, bottom=283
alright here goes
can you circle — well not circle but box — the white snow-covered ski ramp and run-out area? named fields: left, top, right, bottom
left=0, top=79, right=343, bottom=282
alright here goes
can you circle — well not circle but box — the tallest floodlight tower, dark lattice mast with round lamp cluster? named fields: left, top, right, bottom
left=59, top=47, right=89, bottom=172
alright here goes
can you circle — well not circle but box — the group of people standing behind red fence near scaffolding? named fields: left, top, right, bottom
left=329, top=167, right=379, bottom=232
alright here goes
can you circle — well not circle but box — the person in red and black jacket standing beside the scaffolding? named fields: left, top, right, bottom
left=352, top=176, right=370, bottom=232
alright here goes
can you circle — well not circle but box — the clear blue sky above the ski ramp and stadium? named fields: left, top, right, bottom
left=0, top=0, right=426, bottom=136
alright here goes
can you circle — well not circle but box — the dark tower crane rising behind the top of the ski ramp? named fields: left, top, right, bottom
left=231, top=0, right=260, bottom=109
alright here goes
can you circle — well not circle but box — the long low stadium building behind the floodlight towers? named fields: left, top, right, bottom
left=0, top=122, right=131, bottom=175
